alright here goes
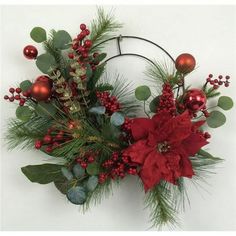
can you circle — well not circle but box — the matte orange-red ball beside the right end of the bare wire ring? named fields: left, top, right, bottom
left=175, top=53, right=196, bottom=74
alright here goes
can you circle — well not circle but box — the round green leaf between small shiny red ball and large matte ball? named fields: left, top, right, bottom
left=36, top=53, right=57, bottom=74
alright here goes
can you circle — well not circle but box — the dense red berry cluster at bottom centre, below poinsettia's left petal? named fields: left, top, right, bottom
left=99, top=152, right=138, bottom=183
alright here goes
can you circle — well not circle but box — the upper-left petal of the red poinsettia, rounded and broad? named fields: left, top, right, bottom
left=131, top=118, right=155, bottom=141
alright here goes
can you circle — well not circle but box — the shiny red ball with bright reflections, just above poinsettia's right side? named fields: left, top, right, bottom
left=184, top=89, right=207, bottom=112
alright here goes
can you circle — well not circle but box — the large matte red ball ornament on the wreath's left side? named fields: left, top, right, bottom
left=30, top=81, right=52, bottom=101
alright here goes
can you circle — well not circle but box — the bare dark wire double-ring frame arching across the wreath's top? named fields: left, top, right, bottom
left=93, top=35, right=175, bottom=66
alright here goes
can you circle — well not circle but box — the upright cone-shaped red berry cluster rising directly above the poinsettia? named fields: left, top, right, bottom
left=157, top=83, right=176, bottom=115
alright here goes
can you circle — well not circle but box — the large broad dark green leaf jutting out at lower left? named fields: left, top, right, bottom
left=21, top=164, right=62, bottom=184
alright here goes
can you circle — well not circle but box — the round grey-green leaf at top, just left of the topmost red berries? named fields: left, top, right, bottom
left=53, top=30, right=72, bottom=50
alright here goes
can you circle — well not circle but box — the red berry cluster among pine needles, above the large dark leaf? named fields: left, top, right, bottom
left=34, top=128, right=72, bottom=153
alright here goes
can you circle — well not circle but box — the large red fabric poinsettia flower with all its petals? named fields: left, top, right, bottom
left=124, top=112, right=208, bottom=191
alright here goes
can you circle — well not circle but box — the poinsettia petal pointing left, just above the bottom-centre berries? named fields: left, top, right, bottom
left=123, top=140, right=153, bottom=164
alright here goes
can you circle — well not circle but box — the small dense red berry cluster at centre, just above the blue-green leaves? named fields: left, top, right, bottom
left=96, top=92, right=121, bottom=115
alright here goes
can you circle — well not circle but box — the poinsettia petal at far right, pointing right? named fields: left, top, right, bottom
left=181, top=133, right=208, bottom=156
